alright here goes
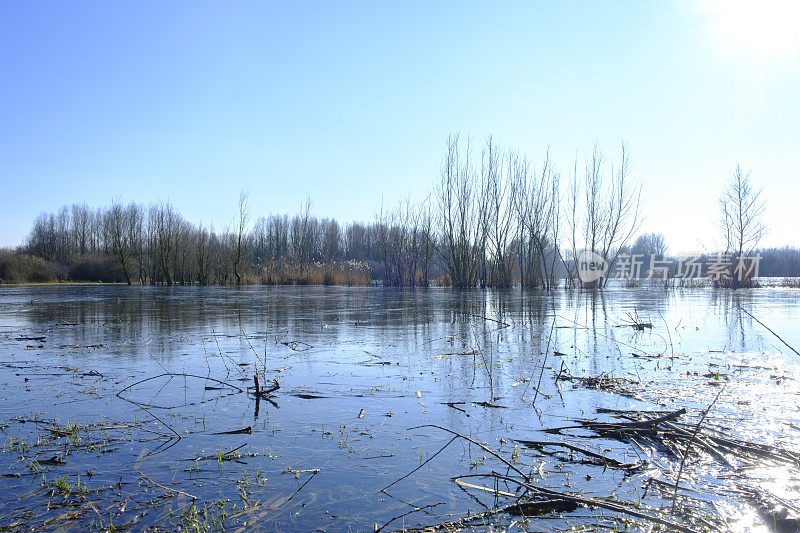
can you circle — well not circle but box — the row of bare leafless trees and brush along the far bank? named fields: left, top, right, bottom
left=0, top=135, right=796, bottom=289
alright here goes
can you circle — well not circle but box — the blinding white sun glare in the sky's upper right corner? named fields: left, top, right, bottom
left=700, top=0, right=800, bottom=68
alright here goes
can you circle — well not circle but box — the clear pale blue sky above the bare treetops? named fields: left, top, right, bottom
left=0, top=0, right=800, bottom=252
